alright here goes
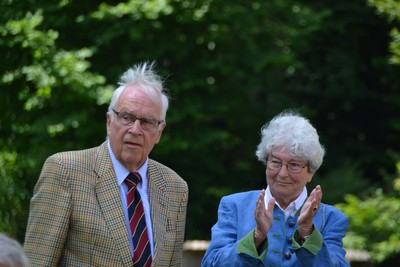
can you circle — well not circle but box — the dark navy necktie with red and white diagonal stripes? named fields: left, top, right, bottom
left=125, top=173, right=152, bottom=267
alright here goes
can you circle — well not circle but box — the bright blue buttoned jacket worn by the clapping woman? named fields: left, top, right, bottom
left=202, top=190, right=349, bottom=267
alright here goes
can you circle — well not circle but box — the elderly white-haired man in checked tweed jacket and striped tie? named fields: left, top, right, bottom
left=24, top=63, right=188, bottom=267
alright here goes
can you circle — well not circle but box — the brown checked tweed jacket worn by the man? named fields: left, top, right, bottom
left=24, top=142, right=188, bottom=267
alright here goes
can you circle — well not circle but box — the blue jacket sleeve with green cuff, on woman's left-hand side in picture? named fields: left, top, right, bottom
left=202, top=197, right=265, bottom=267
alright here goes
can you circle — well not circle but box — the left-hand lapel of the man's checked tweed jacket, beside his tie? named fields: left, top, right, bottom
left=94, top=142, right=132, bottom=266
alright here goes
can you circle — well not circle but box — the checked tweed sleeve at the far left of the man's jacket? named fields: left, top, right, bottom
left=24, top=156, right=71, bottom=266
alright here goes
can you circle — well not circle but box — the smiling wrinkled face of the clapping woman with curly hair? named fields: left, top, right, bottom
left=266, top=147, right=314, bottom=208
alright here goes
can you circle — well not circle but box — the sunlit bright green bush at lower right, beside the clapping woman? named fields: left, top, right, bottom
left=337, top=163, right=400, bottom=266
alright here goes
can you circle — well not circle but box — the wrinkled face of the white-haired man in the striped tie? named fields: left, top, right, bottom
left=107, top=85, right=166, bottom=172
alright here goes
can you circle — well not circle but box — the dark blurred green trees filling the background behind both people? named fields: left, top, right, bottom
left=0, top=0, right=400, bottom=264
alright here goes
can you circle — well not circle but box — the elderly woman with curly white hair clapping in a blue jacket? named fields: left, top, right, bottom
left=202, top=111, right=350, bottom=267
